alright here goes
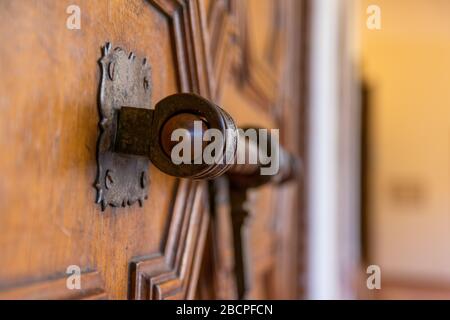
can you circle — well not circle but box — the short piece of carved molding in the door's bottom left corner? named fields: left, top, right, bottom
left=0, top=271, right=107, bottom=300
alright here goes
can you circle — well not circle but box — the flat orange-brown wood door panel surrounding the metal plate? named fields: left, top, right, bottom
left=0, top=0, right=202, bottom=298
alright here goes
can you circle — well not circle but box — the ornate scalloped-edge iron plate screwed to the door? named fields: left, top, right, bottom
left=95, top=43, right=152, bottom=210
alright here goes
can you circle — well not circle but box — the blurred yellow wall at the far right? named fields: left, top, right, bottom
left=358, top=0, right=450, bottom=283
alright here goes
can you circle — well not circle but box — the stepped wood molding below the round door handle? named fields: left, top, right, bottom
left=130, top=180, right=209, bottom=300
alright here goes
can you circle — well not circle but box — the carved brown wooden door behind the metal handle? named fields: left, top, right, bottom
left=0, top=0, right=305, bottom=299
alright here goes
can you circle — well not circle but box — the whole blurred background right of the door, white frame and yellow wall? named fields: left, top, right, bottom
left=308, top=0, right=450, bottom=299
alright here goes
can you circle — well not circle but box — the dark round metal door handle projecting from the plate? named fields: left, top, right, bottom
left=114, top=93, right=298, bottom=186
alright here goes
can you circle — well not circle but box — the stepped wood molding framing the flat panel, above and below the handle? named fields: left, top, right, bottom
left=119, top=0, right=211, bottom=300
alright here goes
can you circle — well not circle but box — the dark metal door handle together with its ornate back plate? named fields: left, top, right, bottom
left=96, top=44, right=296, bottom=210
